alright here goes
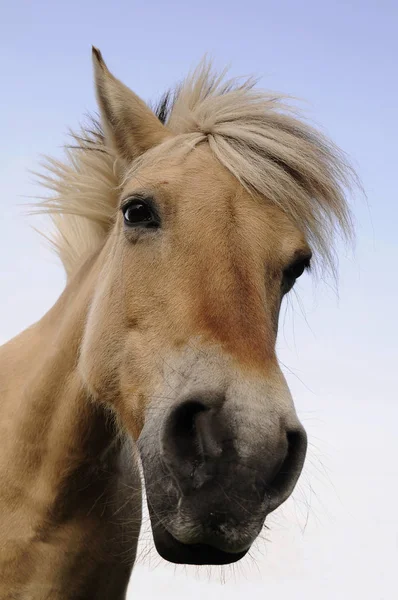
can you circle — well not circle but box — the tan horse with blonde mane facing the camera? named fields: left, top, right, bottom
left=0, top=48, right=352, bottom=600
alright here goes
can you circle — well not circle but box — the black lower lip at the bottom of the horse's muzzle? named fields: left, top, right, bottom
left=153, top=524, right=249, bottom=565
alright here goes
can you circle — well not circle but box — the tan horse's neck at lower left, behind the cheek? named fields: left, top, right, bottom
left=0, top=254, right=139, bottom=598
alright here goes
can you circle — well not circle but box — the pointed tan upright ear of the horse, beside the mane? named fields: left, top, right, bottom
left=93, top=47, right=172, bottom=161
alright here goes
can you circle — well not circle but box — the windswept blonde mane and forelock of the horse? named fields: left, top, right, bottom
left=38, top=62, right=355, bottom=276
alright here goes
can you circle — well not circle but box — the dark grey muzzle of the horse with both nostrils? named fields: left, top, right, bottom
left=141, top=393, right=307, bottom=564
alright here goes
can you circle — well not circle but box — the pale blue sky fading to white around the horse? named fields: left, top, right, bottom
left=0, top=0, right=398, bottom=600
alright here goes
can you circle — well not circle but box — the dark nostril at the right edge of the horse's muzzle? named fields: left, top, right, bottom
left=268, top=429, right=307, bottom=511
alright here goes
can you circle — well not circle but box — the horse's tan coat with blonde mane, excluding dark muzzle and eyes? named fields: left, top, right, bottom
left=0, top=52, right=349, bottom=600
